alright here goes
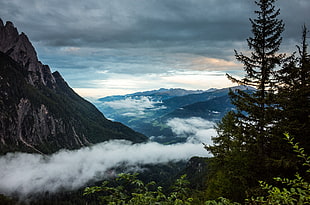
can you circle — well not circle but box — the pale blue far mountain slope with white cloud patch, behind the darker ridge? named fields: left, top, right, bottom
left=93, top=88, right=203, bottom=125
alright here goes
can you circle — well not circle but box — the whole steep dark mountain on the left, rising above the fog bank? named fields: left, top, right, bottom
left=0, top=19, right=147, bottom=154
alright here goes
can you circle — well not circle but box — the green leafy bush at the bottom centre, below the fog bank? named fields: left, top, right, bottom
left=84, top=173, right=193, bottom=205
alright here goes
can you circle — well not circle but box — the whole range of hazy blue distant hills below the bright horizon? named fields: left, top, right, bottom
left=95, top=86, right=253, bottom=143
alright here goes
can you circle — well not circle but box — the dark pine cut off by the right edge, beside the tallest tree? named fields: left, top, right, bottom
left=278, top=26, right=310, bottom=154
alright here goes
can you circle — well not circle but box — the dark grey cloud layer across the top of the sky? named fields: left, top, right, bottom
left=0, top=0, right=310, bottom=50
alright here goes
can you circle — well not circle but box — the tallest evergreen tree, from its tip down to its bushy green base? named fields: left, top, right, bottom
left=206, top=0, right=284, bottom=200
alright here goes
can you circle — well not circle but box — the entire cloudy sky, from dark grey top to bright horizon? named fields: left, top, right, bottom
left=0, top=0, right=310, bottom=97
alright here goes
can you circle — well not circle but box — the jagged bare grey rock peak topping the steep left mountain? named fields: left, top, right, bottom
left=0, top=19, right=56, bottom=88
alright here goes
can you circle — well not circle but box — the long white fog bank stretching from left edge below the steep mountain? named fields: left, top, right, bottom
left=0, top=140, right=209, bottom=197
